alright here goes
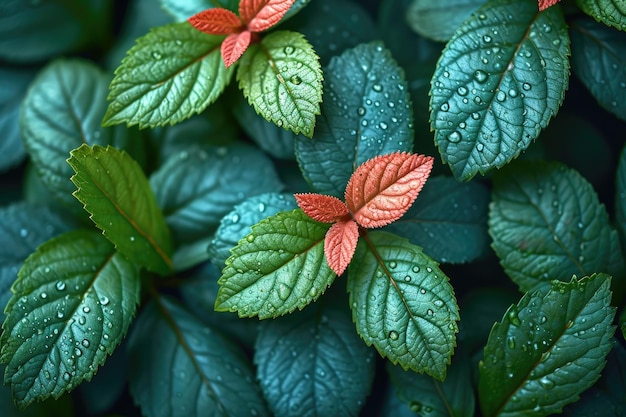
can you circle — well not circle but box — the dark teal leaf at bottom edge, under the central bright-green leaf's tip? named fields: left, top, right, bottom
left=387, top=351, right=475, bottom=417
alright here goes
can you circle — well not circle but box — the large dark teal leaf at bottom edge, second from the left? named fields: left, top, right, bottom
left=128, top=298, right=269, bottom=417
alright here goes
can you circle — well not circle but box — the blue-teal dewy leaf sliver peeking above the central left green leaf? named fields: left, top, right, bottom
left=208, top=193, right=298, bottom=265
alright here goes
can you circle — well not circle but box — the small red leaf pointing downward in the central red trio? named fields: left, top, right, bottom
left=324, top=219, right=359, bottom=275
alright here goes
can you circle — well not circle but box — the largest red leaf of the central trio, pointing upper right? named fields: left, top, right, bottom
left=346, top=152, right=433, bottom=228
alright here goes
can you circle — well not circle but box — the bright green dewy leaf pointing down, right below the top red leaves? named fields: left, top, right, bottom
left=237, top=30, right=322, bottom=137
